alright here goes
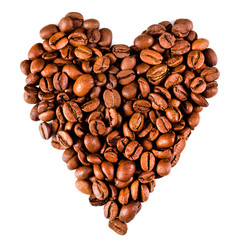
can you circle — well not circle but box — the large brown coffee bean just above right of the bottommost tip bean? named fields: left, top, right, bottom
left=119, top=202, right=142, bottom=223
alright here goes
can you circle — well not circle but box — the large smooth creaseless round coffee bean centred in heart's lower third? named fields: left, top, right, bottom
left=116, top=160, right=136, bottom=182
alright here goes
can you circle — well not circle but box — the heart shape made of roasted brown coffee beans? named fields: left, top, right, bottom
left=20, top=12, right=220, bottom=235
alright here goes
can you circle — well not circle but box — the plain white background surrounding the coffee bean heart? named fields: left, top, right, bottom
left=0, top=0, right=240, bottom=240
